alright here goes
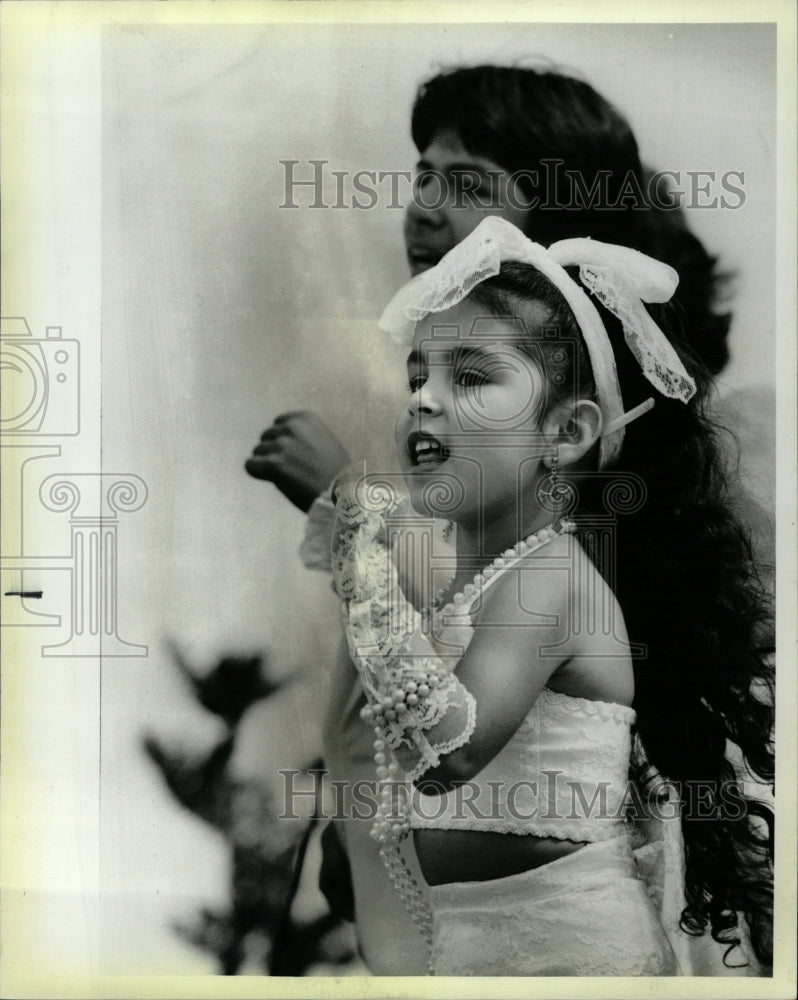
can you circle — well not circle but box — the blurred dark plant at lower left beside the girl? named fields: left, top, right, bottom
left=144, top=646, right=353, bottom=976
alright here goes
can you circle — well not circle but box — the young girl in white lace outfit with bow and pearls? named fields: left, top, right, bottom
left=333, top=217, right=773, bottom=976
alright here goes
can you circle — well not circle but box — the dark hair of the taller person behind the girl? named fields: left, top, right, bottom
left=411, top=65, right=731, bottom=374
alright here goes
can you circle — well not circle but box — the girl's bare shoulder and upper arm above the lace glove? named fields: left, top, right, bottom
left=419, top=536, right=634, bottom=792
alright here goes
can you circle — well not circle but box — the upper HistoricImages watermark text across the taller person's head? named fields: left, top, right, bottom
left=278, top=159, right=747, bottom=212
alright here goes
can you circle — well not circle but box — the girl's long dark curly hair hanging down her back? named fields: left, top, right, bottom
left=471, top=264, right=774, bottom=965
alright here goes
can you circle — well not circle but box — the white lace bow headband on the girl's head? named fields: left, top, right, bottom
left=380, top=216, right=696, bottom=467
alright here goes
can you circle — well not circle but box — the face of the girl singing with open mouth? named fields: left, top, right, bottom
left=396, top=299, right=551, bottom=527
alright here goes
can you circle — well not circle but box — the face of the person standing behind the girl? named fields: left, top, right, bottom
left=405, top=132, right=530, bottom=275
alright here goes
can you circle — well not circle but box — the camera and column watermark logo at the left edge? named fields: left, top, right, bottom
left=0, top=316, right=148, bottom=658
